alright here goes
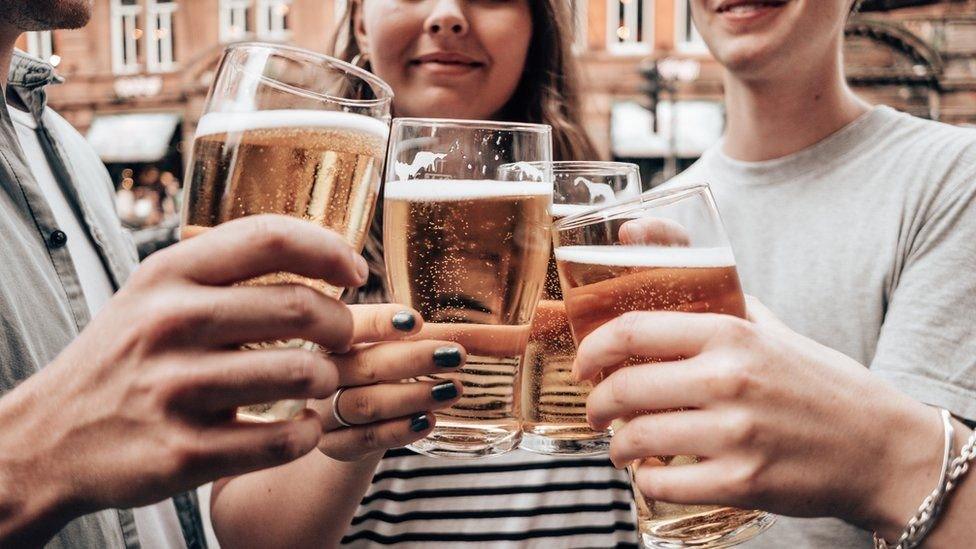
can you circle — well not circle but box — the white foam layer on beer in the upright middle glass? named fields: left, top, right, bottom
left=383, top=179, right=552, bottom=202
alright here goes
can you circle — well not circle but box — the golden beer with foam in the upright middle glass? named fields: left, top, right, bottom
left=383, top=179, right=552, bottom=455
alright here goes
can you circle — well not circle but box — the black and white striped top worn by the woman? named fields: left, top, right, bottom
left=342, top=450, right=638, bottom=549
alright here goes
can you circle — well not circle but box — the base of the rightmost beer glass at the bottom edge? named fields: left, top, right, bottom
left=640, top=508, right=776, bottom=549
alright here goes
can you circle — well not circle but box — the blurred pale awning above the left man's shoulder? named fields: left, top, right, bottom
left=87, top=113, right=180, bottom=164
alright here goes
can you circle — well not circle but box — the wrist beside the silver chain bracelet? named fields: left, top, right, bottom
left=858, top=399, right=944, bottom=541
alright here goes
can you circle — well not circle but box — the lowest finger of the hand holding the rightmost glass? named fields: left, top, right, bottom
left=634, top=459, right=742, bottom=506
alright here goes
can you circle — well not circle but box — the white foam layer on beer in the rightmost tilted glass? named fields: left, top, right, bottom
left=555, top=246, right=735, bottom=268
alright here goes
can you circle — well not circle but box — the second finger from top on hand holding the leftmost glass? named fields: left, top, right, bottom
left=183, top=284, right=354, bottom=352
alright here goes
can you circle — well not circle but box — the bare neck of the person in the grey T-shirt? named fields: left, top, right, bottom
left=723, top=50, right=870, bottom=162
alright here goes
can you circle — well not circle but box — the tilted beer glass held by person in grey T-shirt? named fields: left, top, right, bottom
left=553, top=185, right=774, bottom=548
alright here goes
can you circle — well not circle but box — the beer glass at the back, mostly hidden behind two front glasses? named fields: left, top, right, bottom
left=506, top=161, right=641, bottom=455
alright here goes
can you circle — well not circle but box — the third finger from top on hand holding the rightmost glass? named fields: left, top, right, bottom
left=610, top=410, right=721, bottom=467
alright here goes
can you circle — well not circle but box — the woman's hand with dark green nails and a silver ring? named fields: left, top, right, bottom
left=312, top=305, right=465, bottom=461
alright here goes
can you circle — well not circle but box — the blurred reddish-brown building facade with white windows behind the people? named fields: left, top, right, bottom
left=19, top=0, right=976, bottom=195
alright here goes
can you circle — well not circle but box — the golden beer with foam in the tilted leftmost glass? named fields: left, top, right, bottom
left=181, top=110, right=389, bottom=421
